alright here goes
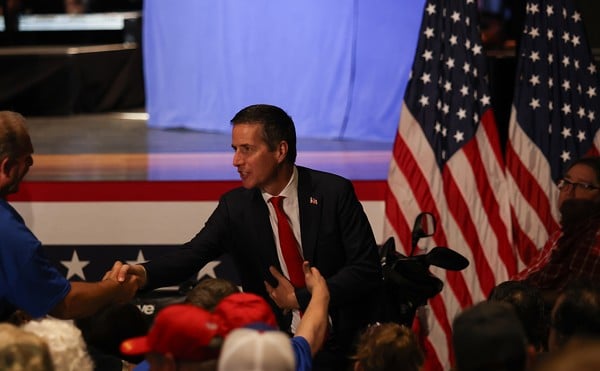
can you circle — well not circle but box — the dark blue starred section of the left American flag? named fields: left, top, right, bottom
left=406, top=1, right=490, bottom=166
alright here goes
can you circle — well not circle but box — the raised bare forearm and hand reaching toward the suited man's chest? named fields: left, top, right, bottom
left=295, top=261, right=329, bottom=356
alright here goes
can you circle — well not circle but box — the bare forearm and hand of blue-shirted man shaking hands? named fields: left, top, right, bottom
left=49, top=262, right=140, bottom=319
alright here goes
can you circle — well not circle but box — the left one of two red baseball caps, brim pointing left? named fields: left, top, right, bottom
left=121, top=304, right=220, bottom=361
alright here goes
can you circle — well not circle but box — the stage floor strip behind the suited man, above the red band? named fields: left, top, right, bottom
left=27, top=111, right=392, bottom=181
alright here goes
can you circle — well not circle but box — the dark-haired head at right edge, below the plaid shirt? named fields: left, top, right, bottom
left=548, top=286, right=600, bottom=351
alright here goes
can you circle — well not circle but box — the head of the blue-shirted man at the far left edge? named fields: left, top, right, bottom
left=0, top=111, right=33, bottom=198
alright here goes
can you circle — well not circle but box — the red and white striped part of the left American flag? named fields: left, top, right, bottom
left=386, top=107, right=514, bottom=366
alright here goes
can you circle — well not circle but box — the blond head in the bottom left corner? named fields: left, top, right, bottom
left=0, top=323, right=58, bottom=371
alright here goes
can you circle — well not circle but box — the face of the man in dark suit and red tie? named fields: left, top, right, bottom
left=231, top=123, right=284, bottom=194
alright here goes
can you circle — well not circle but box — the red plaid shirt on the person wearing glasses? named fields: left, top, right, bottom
left=512, top=230, right=600, bottom=290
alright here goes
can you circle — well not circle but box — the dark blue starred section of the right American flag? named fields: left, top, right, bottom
left=515, top=1, right=599, bottom=173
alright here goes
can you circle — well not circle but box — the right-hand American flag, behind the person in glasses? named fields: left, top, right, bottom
left=506, top=0, right=600, bottom=268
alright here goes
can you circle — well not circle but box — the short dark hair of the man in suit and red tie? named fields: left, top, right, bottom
left=231, top=104, right=296, bottom=164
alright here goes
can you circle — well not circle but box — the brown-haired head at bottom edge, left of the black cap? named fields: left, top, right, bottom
left=353, top=323, right=425, bottom=371
